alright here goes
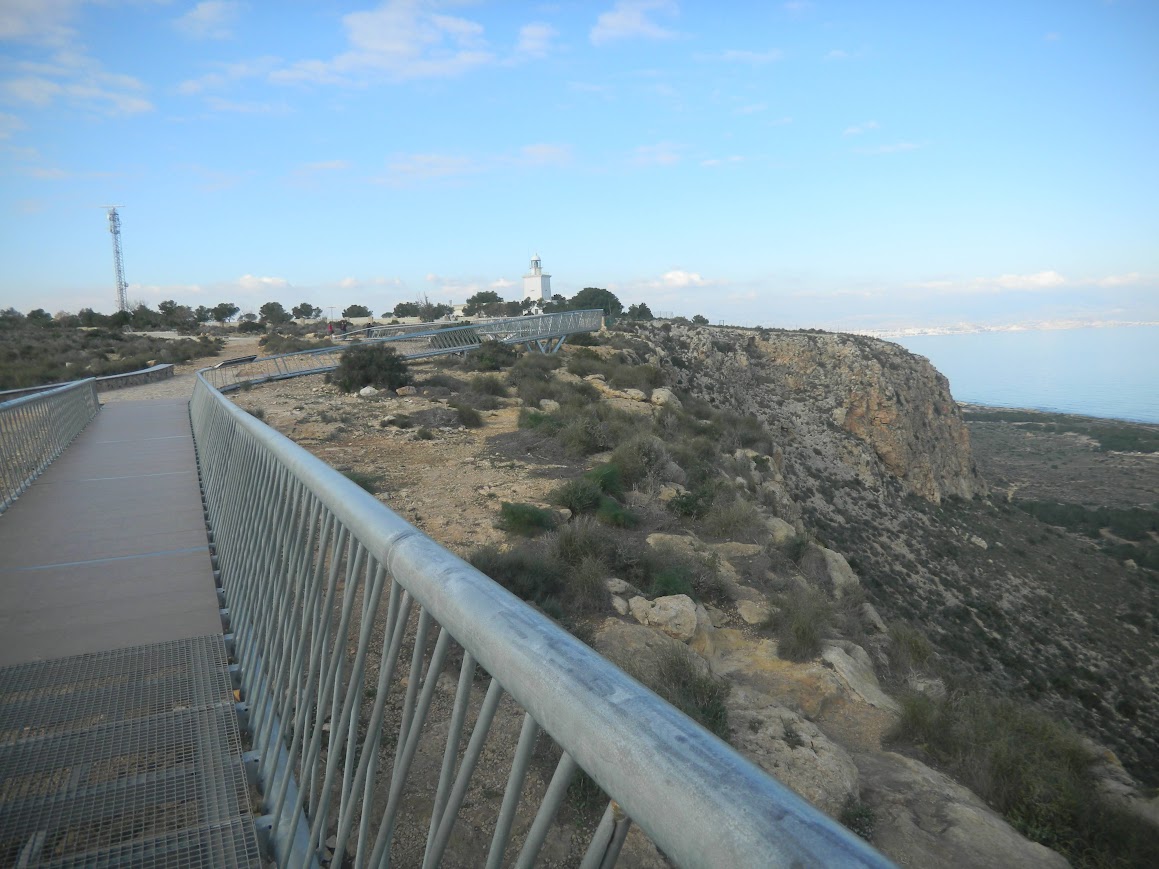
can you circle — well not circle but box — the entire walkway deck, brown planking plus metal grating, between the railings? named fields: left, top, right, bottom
left=0, top=400, right=260, bottom=867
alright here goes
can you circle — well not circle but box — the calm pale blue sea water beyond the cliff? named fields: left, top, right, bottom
left=890, top=326, right=1159, bottom=423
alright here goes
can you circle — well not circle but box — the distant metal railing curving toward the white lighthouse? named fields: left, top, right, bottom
left=203, top=309, right=604, bottom=389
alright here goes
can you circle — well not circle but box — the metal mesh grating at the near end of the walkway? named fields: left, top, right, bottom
left=0, top=635, right=261, bottom=868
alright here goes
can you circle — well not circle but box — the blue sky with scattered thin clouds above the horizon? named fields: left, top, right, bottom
left=0, top=0, right=1159, bottom=329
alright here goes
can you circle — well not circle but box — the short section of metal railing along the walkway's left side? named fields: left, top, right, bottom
left=0, top=378, right=101, bottom=513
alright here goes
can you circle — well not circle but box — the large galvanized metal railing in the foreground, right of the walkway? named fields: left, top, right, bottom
left=190, top=372, right=889, bottom=869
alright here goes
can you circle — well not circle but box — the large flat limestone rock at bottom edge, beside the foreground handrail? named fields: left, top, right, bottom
left=854, top=752, right=1070, bottom=869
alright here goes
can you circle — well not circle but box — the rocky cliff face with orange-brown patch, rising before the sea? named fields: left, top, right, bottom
left=642, top=324, right=985, bottom=503
